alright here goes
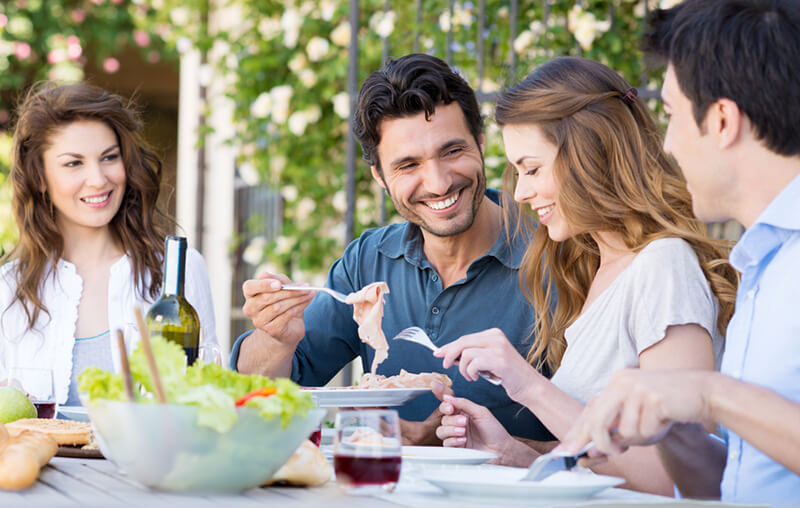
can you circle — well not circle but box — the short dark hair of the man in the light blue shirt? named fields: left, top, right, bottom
left=643, top=0, right=800, bottom=156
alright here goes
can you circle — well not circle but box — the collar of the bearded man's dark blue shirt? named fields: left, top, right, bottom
left=378, top=189, right=528, bottom=270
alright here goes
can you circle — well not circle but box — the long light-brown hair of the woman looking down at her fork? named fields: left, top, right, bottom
left=496, top=57, right=738, bottom=372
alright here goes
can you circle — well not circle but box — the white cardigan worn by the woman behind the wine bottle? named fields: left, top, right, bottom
left=0, top=249, right=217, bottom=404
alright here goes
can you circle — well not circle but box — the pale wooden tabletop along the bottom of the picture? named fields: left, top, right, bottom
left=0, top=457, right=760, bottom=508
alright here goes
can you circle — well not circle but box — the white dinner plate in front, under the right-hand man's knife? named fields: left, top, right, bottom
left=424, top=467, right=625, bottom=500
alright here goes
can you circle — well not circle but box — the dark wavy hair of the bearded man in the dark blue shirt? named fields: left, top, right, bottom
left=353, top=53, right=483, bottom=171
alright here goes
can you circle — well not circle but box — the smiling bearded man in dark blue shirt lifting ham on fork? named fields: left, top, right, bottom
left=231, top=54, right=552, bottom=444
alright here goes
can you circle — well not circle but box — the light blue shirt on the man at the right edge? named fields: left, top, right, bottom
left=721, top=176, right=800, bottom=504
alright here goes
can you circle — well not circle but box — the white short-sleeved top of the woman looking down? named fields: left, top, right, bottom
left=552, top=238, right=724, bottom=404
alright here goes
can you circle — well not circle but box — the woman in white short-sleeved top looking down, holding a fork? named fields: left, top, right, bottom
left=437, top=58, right=737, bottom=495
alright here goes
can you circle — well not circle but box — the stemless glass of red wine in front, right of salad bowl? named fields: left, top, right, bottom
left=333, top=409, right=402, bottom=495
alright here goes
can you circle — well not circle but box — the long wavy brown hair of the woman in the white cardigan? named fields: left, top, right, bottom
left=2, top=83, right=170, bottom=329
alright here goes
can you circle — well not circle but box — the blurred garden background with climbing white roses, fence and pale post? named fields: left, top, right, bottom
left=0, top=0, right=740, bottom=364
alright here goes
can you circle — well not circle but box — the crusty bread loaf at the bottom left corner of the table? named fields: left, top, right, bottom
left=0, top=424, right=58, bottom=490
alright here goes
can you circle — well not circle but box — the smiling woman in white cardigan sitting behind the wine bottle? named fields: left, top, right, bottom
left=0, top=83, right=216, bottom=405
